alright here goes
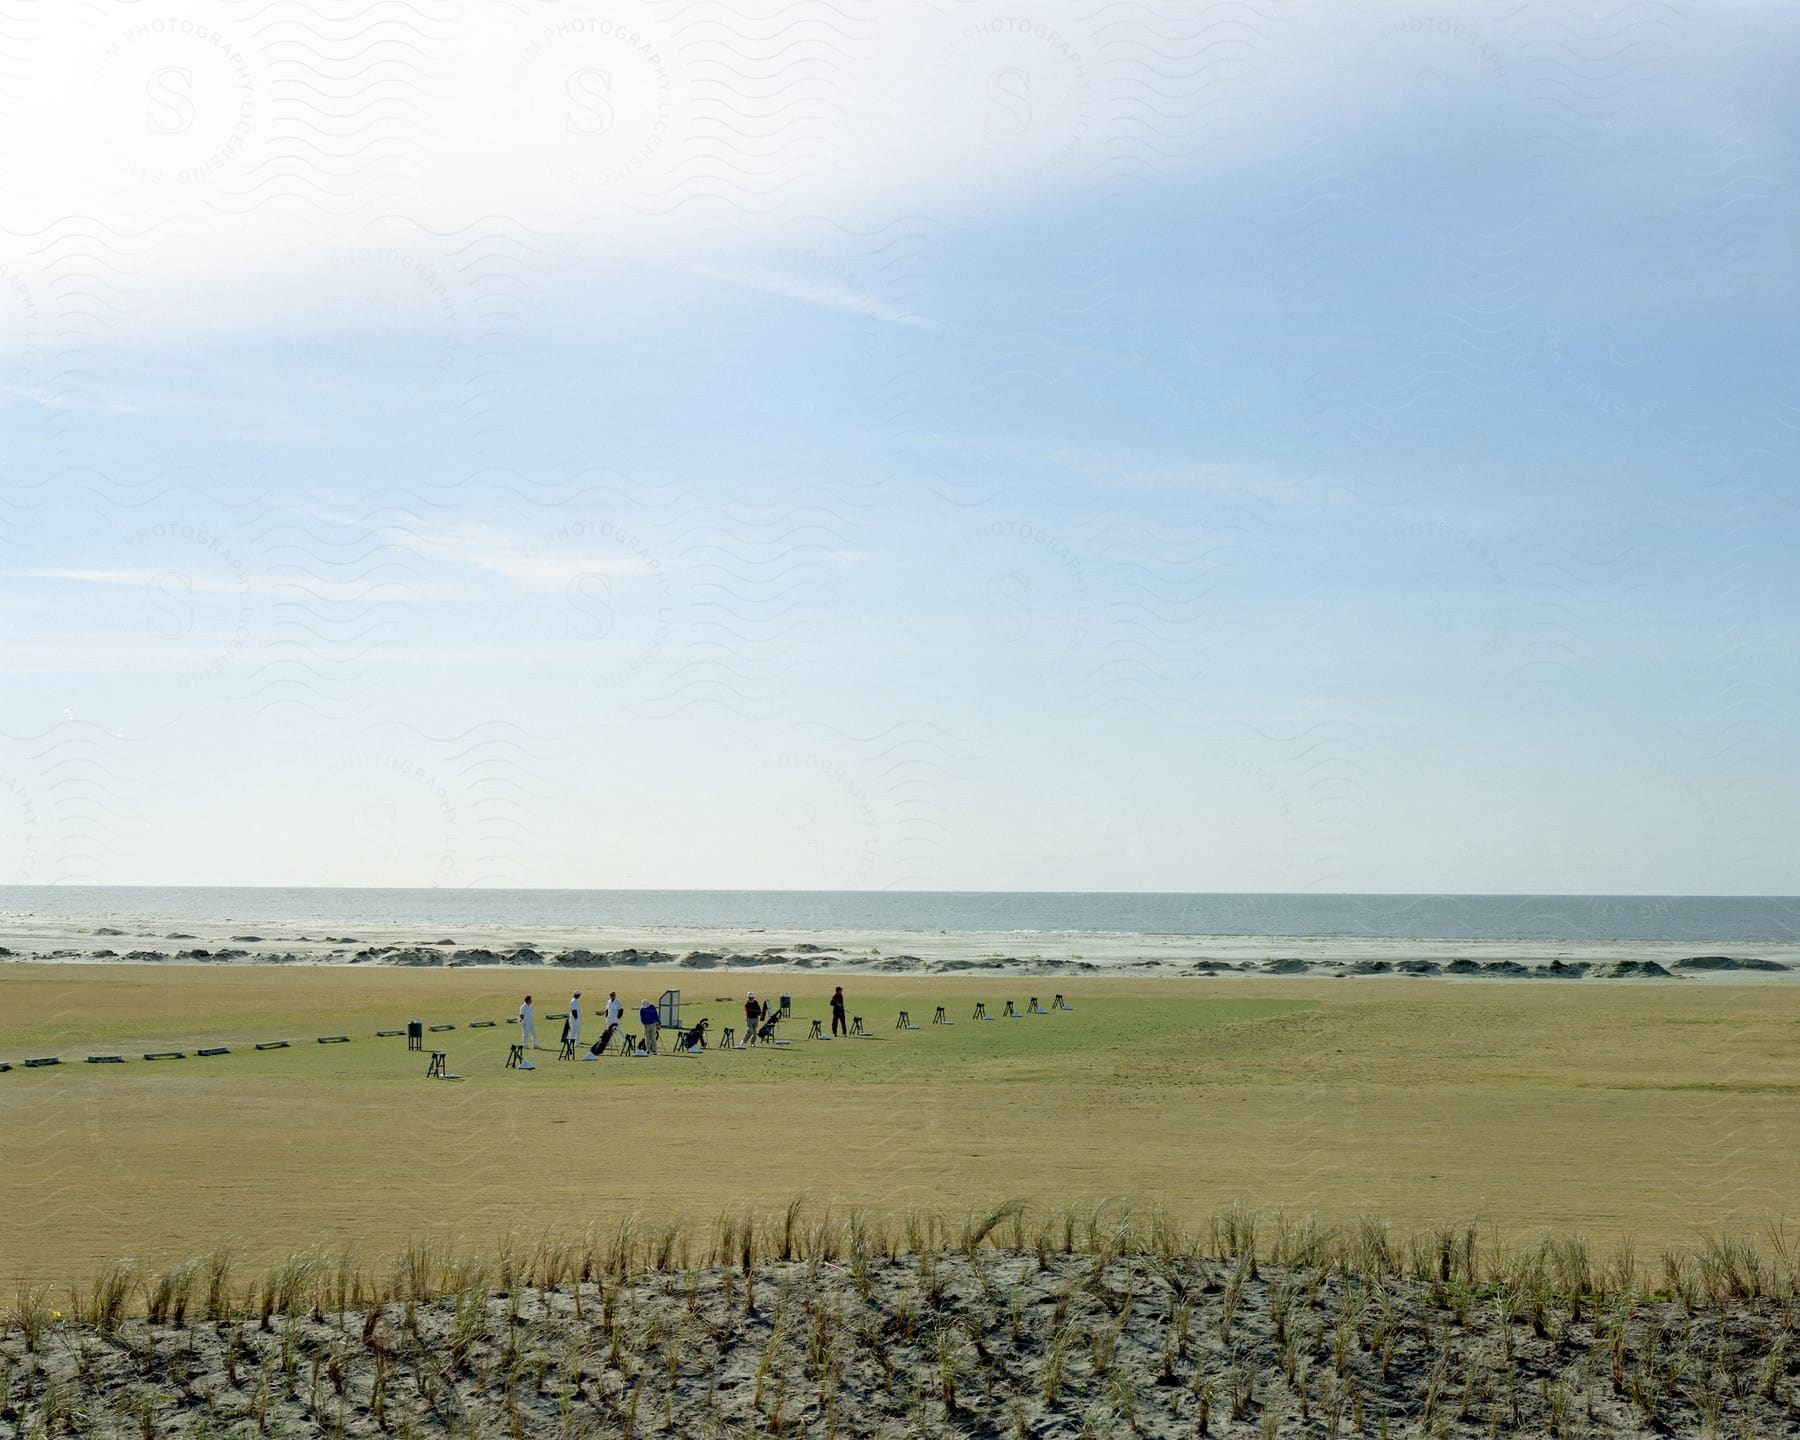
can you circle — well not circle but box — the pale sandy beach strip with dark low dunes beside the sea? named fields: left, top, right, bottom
left=0, top=914, right=1800, bottom=985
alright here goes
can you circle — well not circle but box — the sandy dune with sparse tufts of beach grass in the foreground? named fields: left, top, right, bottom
left=0, top=1197, right=1800, bottom=1440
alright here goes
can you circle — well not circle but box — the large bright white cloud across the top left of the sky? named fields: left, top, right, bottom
left=28, top=0, right=1756, bottom=342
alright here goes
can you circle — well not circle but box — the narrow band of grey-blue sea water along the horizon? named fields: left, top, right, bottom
left=0, top=886, right=1800, bottom=945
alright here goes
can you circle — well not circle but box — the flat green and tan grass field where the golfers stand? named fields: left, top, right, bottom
left=0, top=965, right=1800, bottom=1282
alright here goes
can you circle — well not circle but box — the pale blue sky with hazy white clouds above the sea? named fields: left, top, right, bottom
left=0, top=0, right=1800, bottom=895
